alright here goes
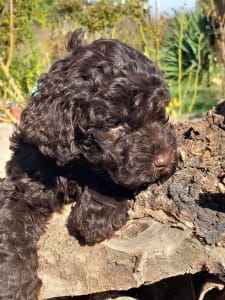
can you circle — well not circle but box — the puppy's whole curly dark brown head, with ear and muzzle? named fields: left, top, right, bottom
left=19, top=31, right=176, bottom=189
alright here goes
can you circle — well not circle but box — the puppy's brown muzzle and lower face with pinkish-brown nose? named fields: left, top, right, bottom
left=76, top=122, right=177, bottom=189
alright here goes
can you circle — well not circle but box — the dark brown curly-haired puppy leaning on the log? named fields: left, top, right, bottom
left=0, top=30, right=177, bottom=300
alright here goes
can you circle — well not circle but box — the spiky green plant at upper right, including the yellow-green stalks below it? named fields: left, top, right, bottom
left=161, top=12, right=212, bottom=115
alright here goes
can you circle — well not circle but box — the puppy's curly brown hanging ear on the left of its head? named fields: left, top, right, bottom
left=17, top=91, right=80, bottom=165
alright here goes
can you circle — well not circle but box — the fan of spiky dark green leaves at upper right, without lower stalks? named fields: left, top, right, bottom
left=161, top=12, right=211, bottom=82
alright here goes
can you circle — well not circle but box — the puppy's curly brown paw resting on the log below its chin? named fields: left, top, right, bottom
left=67, top=187, right=128, bottom=245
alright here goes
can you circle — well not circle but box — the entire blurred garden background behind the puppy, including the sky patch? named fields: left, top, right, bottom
left=0, top=0, right=225, bottom=123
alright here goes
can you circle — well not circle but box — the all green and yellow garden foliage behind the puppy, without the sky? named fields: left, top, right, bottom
left=0, top=0, right=220, bottom=122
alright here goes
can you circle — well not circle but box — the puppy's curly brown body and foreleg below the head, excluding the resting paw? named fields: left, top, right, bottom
left=0, top=141, right=69, bottom=300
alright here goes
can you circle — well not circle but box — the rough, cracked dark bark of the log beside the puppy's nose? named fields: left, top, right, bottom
left=136, top=102, right=225, bottom=246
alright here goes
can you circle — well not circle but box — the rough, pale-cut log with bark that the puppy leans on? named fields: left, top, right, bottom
left=38, top=102, right=225, bottom=299
